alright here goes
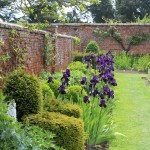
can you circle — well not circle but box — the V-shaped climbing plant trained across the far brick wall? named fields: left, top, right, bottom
left=93, top=26, right=150, bottom=54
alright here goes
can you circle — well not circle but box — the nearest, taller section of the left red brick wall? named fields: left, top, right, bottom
left=0, top=23, right=45, bottom=74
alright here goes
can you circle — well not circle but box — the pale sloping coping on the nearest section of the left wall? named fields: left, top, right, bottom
left=0, top=22, right=46, bottom=34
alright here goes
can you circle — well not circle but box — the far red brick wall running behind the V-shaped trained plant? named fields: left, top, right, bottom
left=48, top=23, right=150, bottom=54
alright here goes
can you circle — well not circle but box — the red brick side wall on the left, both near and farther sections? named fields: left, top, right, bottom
left=0, top=22, right=74, bottom=88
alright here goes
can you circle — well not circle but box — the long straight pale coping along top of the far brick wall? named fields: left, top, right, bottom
left=50, top=23, right=150, bottom=27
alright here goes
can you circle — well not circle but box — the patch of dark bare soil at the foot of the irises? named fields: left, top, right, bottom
left=85, top=142, right=109, bottom=150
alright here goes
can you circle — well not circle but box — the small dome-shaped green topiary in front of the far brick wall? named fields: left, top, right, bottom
left=85, top=41, right=99, bottom=54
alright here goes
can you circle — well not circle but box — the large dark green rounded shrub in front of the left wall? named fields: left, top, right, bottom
left=3, top=70, right=42, bottom=121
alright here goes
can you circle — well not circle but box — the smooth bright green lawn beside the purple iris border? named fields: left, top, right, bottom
left=109, top=73, right=150, bottom=150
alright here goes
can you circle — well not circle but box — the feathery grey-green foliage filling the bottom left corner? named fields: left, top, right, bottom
left=0, top=95, right=61, bottom=150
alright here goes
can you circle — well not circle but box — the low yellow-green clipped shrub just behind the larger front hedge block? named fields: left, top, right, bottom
left=44, top=99, right=82, bottom=118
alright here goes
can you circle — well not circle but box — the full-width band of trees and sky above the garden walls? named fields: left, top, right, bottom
left=0, top=0, right=150, bottom=23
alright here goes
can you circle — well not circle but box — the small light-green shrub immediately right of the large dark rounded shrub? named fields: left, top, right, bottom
left=41, top=81, right=54, bottom=100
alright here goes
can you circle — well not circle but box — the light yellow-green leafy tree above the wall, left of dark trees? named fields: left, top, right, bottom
left=12, top=0, right=99, bottom=23
